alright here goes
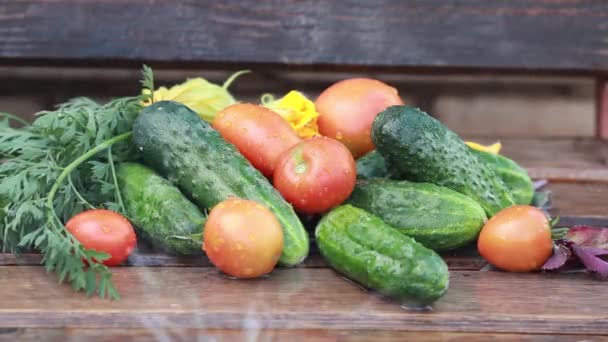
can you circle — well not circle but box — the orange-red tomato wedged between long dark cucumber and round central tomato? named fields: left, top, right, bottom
left=213, top=103, right=300, bottom=177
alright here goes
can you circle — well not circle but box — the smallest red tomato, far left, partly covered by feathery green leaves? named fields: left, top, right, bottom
left=65, top=209, right=137, bottom=266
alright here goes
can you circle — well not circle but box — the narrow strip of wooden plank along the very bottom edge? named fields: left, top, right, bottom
left=0, top=327, right=608, bottom=342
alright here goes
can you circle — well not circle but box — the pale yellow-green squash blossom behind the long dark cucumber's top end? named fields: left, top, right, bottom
left=144, top=70, right=249, bottom=122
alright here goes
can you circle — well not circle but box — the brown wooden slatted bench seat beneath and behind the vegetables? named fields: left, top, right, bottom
left=0, top=144, right=608, bottom=341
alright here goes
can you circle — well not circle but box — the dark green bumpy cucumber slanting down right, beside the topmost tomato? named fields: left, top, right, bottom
left=371, top=106, right=514, bottom=217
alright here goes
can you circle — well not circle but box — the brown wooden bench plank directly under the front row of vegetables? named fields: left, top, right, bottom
left=0, top=266, right=608, bottom=335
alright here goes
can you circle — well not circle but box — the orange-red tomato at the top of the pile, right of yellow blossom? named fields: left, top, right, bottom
left=315, top=78, right=403, bottom=158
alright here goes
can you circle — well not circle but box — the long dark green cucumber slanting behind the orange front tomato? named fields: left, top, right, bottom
left=133, top=101, right=309, bottom=266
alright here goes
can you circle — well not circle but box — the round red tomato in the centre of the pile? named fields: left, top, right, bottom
left=273, top=137, right=357, bottom=214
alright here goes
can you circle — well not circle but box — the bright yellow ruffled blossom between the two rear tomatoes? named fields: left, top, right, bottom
left=262, top=90, right=319, bottom=138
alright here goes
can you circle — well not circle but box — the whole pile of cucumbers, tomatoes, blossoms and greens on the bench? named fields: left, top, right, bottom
left=0, top=67, right=608, bottom=305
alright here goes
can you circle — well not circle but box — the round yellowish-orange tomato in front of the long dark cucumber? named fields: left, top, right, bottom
left=203, top=198, right=283, bottom=278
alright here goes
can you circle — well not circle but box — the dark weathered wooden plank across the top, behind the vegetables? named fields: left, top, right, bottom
left=0, top=0, right=608, bottom=71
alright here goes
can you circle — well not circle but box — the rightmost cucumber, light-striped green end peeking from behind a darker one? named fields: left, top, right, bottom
left=471, top=150, right=534, bottom=205
